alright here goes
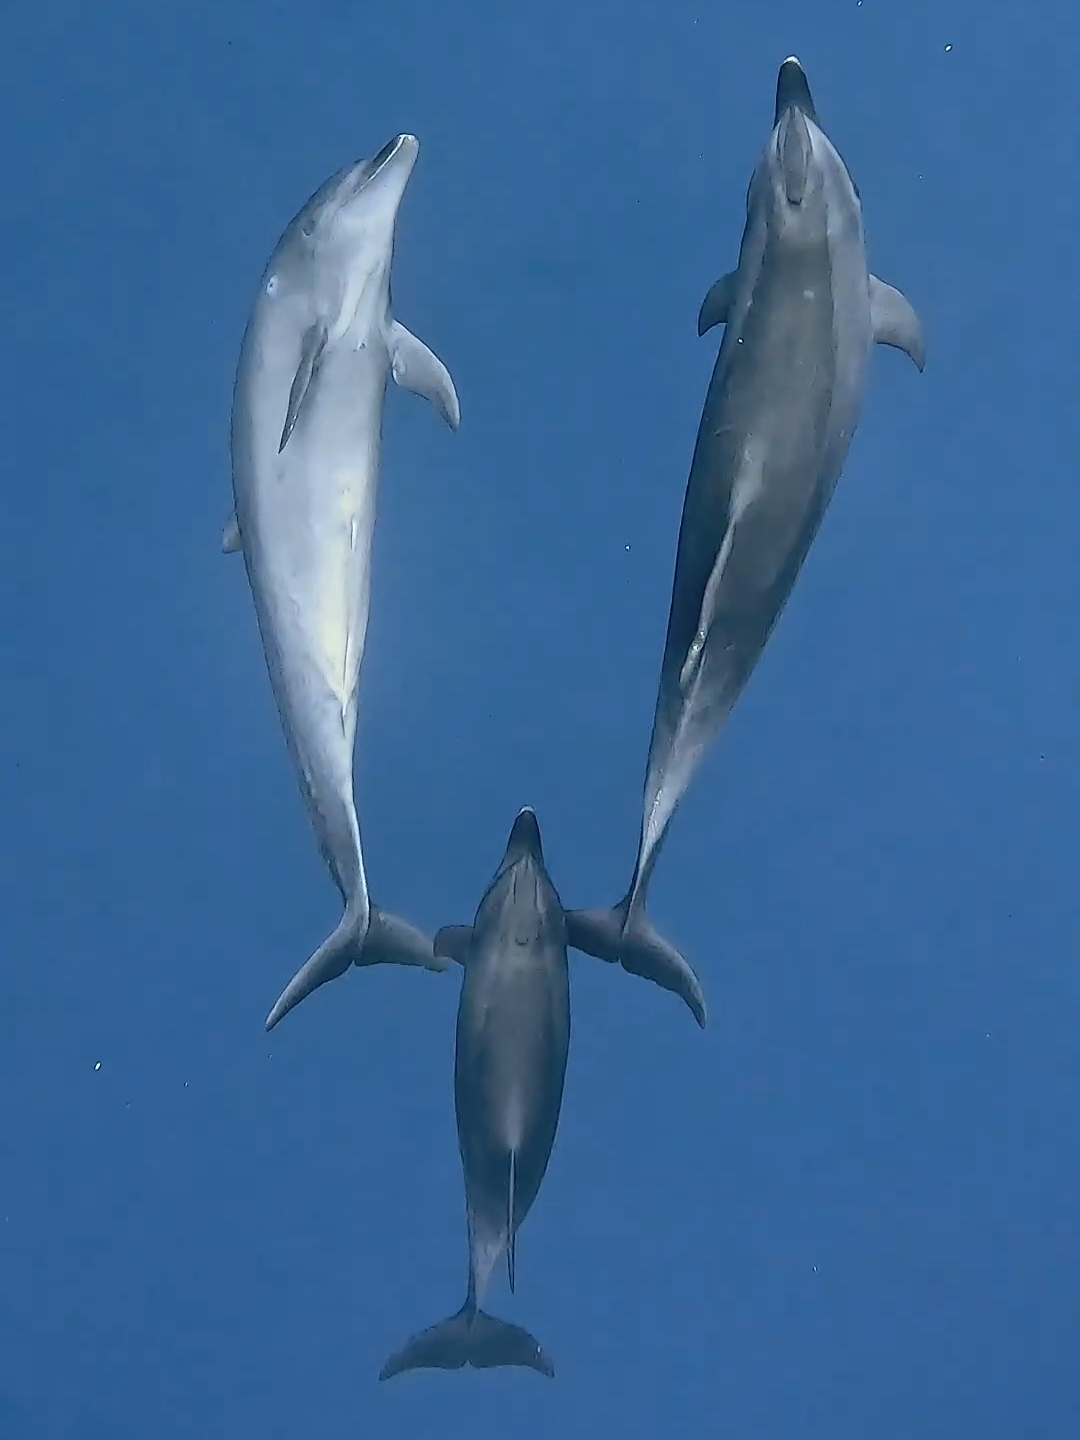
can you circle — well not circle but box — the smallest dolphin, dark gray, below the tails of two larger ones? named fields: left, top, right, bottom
left=379, top=806, right=570, bottom=1380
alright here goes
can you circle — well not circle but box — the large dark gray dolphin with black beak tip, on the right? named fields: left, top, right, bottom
left=566, top=58, right=924, bottom=1025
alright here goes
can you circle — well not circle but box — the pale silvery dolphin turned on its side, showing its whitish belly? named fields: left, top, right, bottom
left=222, top=135, right=459, bottom=1030
